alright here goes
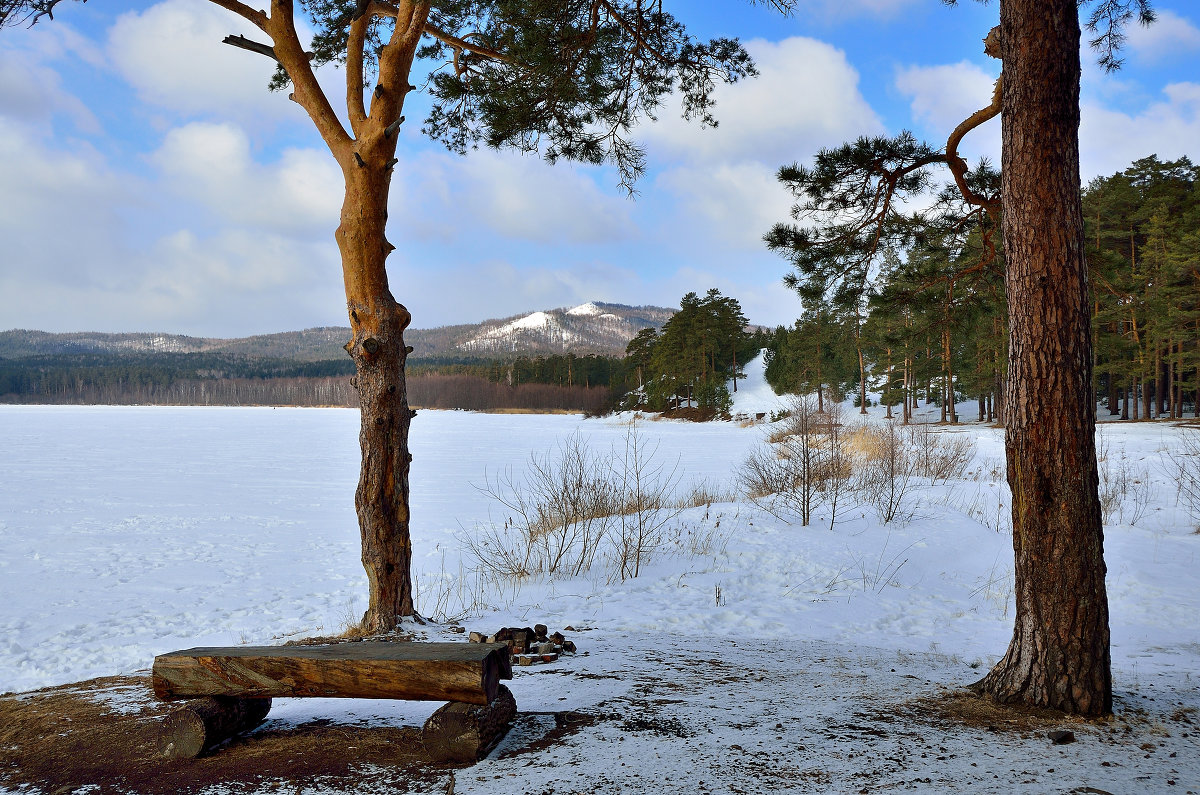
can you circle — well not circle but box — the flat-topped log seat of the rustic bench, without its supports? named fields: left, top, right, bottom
left=152, top=642, right=512, bottom=706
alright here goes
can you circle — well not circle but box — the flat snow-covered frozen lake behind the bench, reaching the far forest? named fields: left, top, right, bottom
left=0, top=406, right=757, bottom=692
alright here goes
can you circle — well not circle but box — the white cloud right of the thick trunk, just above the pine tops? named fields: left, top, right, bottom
left=1079, top=83, right=1200, bottom=183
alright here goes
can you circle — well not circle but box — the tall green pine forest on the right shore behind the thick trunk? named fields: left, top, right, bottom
left=766, top=156, right=1200, bottom=422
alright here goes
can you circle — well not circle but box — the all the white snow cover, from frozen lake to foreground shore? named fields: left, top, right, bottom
left=0, top=357, right=1200, bottom=793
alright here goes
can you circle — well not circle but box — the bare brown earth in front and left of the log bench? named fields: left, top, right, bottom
left=0, top=676, right=445, bottom=795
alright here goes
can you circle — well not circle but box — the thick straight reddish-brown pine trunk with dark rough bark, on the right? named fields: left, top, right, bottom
left=974, top=0, right=1112, bottom=716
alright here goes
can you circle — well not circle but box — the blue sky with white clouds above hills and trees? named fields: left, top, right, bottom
left=0, top=0, right=1200, bottom=336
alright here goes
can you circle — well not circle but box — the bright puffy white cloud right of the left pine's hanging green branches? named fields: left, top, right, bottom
left=638, top=37, right=883, bottom=165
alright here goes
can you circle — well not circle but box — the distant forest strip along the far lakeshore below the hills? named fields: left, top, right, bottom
left=0, top=353, right=625, bottom=413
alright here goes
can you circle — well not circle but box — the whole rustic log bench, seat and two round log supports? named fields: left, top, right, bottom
left=151, top=641, right=516, bottom=761
